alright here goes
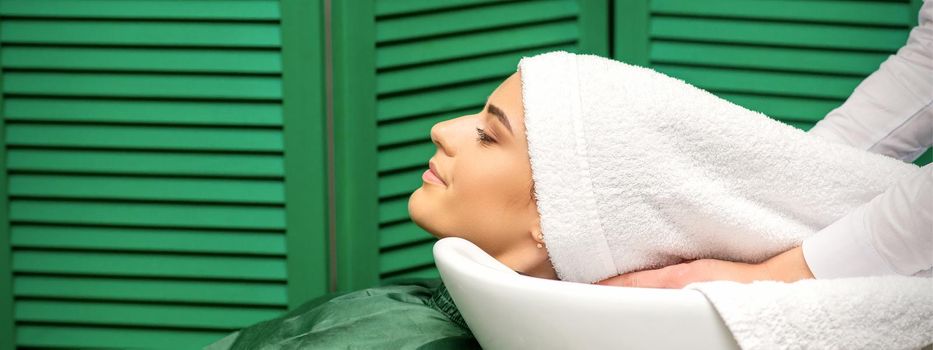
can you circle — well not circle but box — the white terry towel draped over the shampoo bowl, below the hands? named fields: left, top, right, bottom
left=687, top=275, right=933, bottom=350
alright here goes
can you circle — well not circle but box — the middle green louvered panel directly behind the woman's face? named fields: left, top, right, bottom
left=334, top=0, right=609, bottom=286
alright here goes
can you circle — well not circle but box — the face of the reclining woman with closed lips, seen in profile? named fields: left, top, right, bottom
left=408, top=72, right=540, bottom=257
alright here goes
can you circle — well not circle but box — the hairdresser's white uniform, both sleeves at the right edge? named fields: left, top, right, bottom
left=803, top=0, right=933, bottom=278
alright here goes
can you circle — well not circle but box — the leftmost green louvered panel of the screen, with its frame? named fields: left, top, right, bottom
left=0, top=0, right=326, bottom=349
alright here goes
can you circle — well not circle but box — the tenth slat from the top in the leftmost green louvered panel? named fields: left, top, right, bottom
left=10, top=225, right=285, bottom=255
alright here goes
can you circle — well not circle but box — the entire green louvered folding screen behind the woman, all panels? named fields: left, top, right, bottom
left=0, top=0, right=931, bottom=349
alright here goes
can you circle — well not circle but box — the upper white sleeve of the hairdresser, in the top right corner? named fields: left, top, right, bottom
left=809, top=0, right=933, bottom=161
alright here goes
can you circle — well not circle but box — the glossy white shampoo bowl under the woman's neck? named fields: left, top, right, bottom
left=434, top=237, right=739, bottom=350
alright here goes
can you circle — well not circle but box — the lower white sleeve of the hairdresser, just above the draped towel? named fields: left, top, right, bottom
left=802, top=164, right=933, bottom=278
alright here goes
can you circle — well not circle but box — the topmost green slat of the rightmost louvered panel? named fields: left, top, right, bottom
left=650, top=0, right=916, bottom=26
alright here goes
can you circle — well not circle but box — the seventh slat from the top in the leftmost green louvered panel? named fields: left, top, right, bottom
left=7, top=148, right=284, bottom=177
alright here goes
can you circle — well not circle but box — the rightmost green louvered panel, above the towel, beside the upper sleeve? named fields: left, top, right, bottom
left=614, top=0, right=930, bottom=163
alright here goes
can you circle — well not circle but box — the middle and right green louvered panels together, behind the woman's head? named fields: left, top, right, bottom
left=333, top=0, right=930, bottom=289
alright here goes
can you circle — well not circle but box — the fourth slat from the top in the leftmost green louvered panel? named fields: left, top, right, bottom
left=3, top=72, right=282, bottom=99
